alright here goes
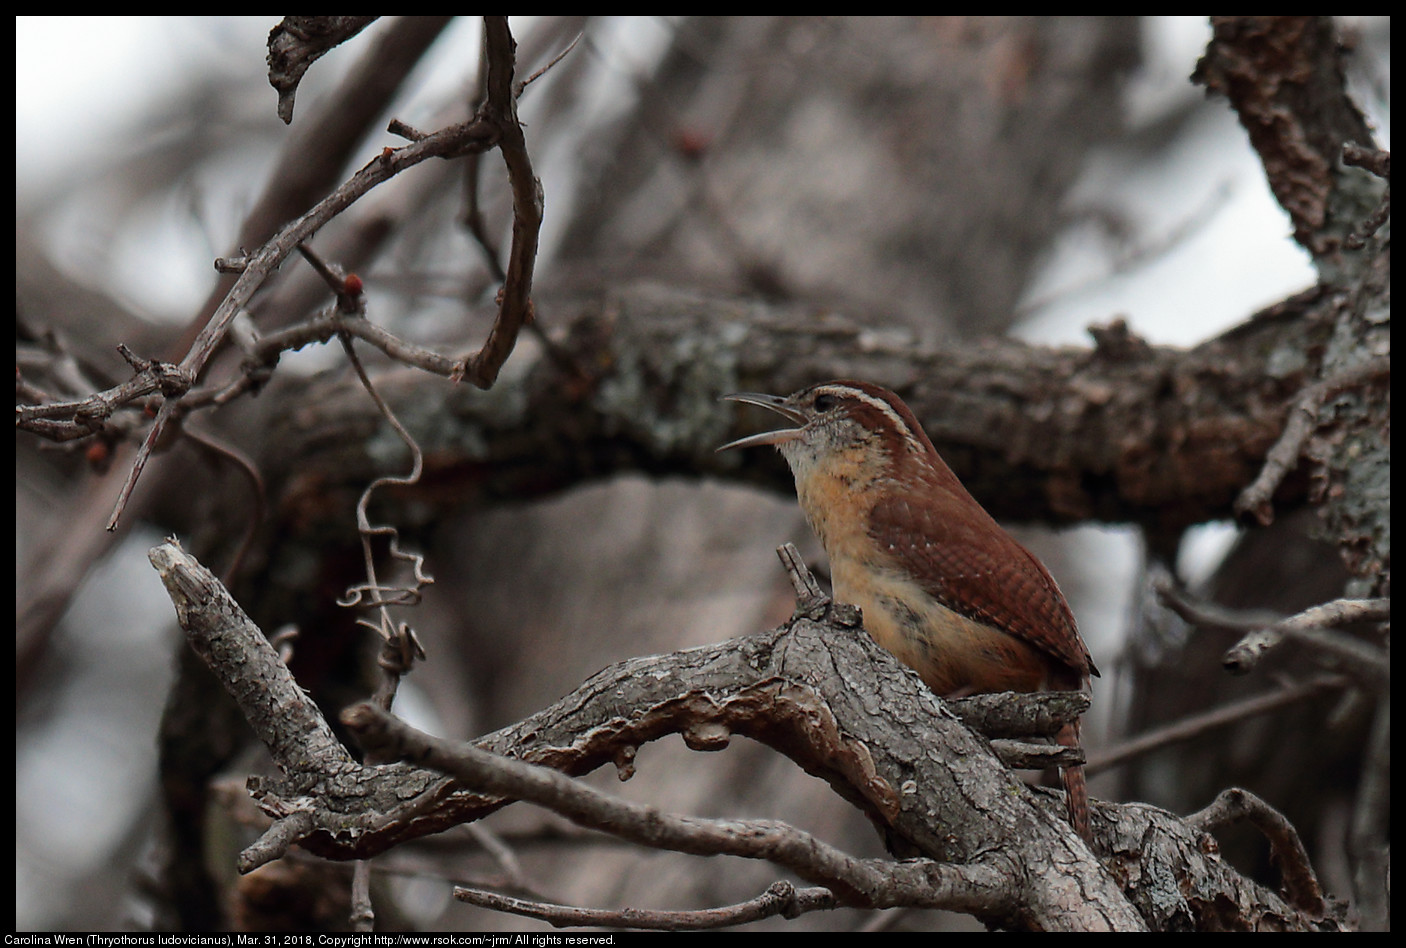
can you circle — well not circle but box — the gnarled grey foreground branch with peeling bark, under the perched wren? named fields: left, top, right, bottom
left=152, top=544, right=1339, bottom=930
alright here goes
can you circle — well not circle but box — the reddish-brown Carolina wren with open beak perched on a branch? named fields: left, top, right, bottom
left=718, top=381, right=1098, bottom=840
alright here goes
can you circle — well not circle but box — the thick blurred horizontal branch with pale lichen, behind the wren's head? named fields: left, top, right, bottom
left=236, top=278, right=1340, bottom=529
